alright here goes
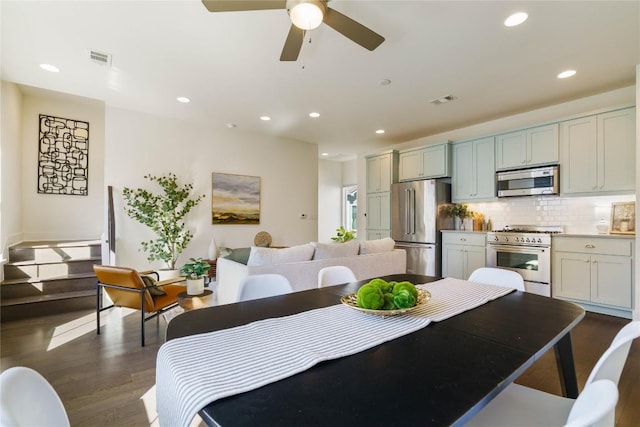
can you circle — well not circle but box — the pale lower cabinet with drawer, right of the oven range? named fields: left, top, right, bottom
left=552, top=237, right=635, bottom=318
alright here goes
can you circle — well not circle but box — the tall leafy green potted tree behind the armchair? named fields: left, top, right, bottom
left=123, top=173, right=205, bottom=270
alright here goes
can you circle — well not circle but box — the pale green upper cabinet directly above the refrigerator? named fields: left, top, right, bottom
left=398, top=141, right=451, bottom=181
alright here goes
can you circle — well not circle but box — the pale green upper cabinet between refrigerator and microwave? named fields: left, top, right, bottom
left=451, top=136, right=496, bottom=203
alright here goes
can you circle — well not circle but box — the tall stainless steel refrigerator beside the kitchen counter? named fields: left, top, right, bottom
left=391, top=179, right=453, bottom=276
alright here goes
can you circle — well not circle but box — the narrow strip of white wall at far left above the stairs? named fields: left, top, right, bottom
left=0, top=81, right=22, bottom=260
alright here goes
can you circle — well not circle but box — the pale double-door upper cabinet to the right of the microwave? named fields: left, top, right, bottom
left=560, top=108, right=636, bottom=194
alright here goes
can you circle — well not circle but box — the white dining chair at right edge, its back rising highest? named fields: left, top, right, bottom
left=468, top=321, right=640, bottom=426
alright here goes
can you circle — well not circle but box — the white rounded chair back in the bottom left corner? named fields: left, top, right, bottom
left=0, top=366, right=70, bottom=427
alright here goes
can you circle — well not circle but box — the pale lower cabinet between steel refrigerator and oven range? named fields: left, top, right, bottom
left=442, top=231, right=487, bottom=280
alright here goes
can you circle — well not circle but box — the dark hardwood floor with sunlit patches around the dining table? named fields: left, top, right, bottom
left=0, top=310, right=640, bottom=427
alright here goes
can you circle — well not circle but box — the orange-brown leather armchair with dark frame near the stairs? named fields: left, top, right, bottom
left=93, top=265, right=186, bottom=347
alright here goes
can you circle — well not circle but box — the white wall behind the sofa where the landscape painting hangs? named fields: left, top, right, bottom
left=105, top=107, right=318, bottom=268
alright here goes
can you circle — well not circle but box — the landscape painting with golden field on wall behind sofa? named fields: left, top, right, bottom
left=211, top=172, right=260, bottom=224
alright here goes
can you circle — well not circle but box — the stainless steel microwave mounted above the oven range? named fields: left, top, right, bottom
left=496, top=165, right=560, bottom=197
